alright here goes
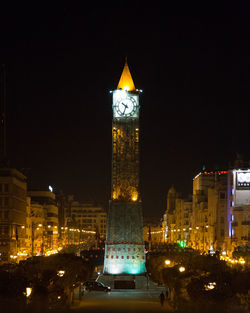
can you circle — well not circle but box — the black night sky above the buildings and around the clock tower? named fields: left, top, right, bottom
left=0, top=1, right=250, bottom=216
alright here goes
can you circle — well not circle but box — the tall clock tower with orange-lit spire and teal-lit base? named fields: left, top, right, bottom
left=104, top=60, right=145, bottom=275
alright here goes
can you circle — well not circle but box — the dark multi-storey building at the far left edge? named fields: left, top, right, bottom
left=0, top=168, right=27, bottom=262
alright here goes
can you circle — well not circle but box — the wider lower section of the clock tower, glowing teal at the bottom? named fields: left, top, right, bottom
left=103, top=201, right=146, bottom=275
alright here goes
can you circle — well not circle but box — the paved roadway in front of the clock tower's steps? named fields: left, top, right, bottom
left=70, top=287, right=171, bottom=313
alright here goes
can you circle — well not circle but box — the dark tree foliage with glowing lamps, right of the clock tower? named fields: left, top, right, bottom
left=146, top=245, right=250, bottom=312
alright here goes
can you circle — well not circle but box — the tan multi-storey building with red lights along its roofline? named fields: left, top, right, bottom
left=190, top=170, right=228, bottom=252
